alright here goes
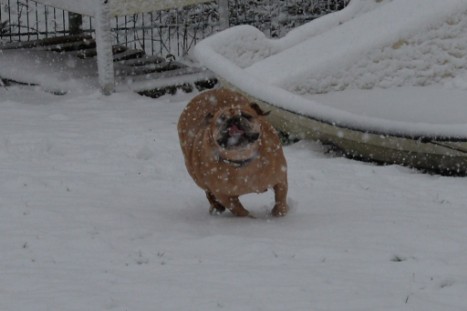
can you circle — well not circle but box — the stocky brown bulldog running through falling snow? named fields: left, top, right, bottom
left=178, top=88, right=288, bottom=216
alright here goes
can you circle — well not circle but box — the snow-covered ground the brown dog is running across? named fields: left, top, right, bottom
left=0, top=87, right=467, bottom=311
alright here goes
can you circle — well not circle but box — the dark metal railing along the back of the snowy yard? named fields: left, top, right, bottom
left=0, top=0, right=350, bottom=57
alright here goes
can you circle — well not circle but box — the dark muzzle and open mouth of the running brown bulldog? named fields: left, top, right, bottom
left=217, top=116, right=259, bottom=149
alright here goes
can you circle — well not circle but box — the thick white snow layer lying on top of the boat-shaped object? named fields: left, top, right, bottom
left=194, top=0, right=467, bottom=138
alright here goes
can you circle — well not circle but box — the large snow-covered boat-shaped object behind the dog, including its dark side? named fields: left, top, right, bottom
left=194, top=0, right=467, bottom=174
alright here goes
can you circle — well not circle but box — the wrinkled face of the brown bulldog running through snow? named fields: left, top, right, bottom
left=214, top=108, right=261, bottom=149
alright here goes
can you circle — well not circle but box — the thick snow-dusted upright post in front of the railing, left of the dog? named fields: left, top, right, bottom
left=95, top=0, right=115, bottom=95
